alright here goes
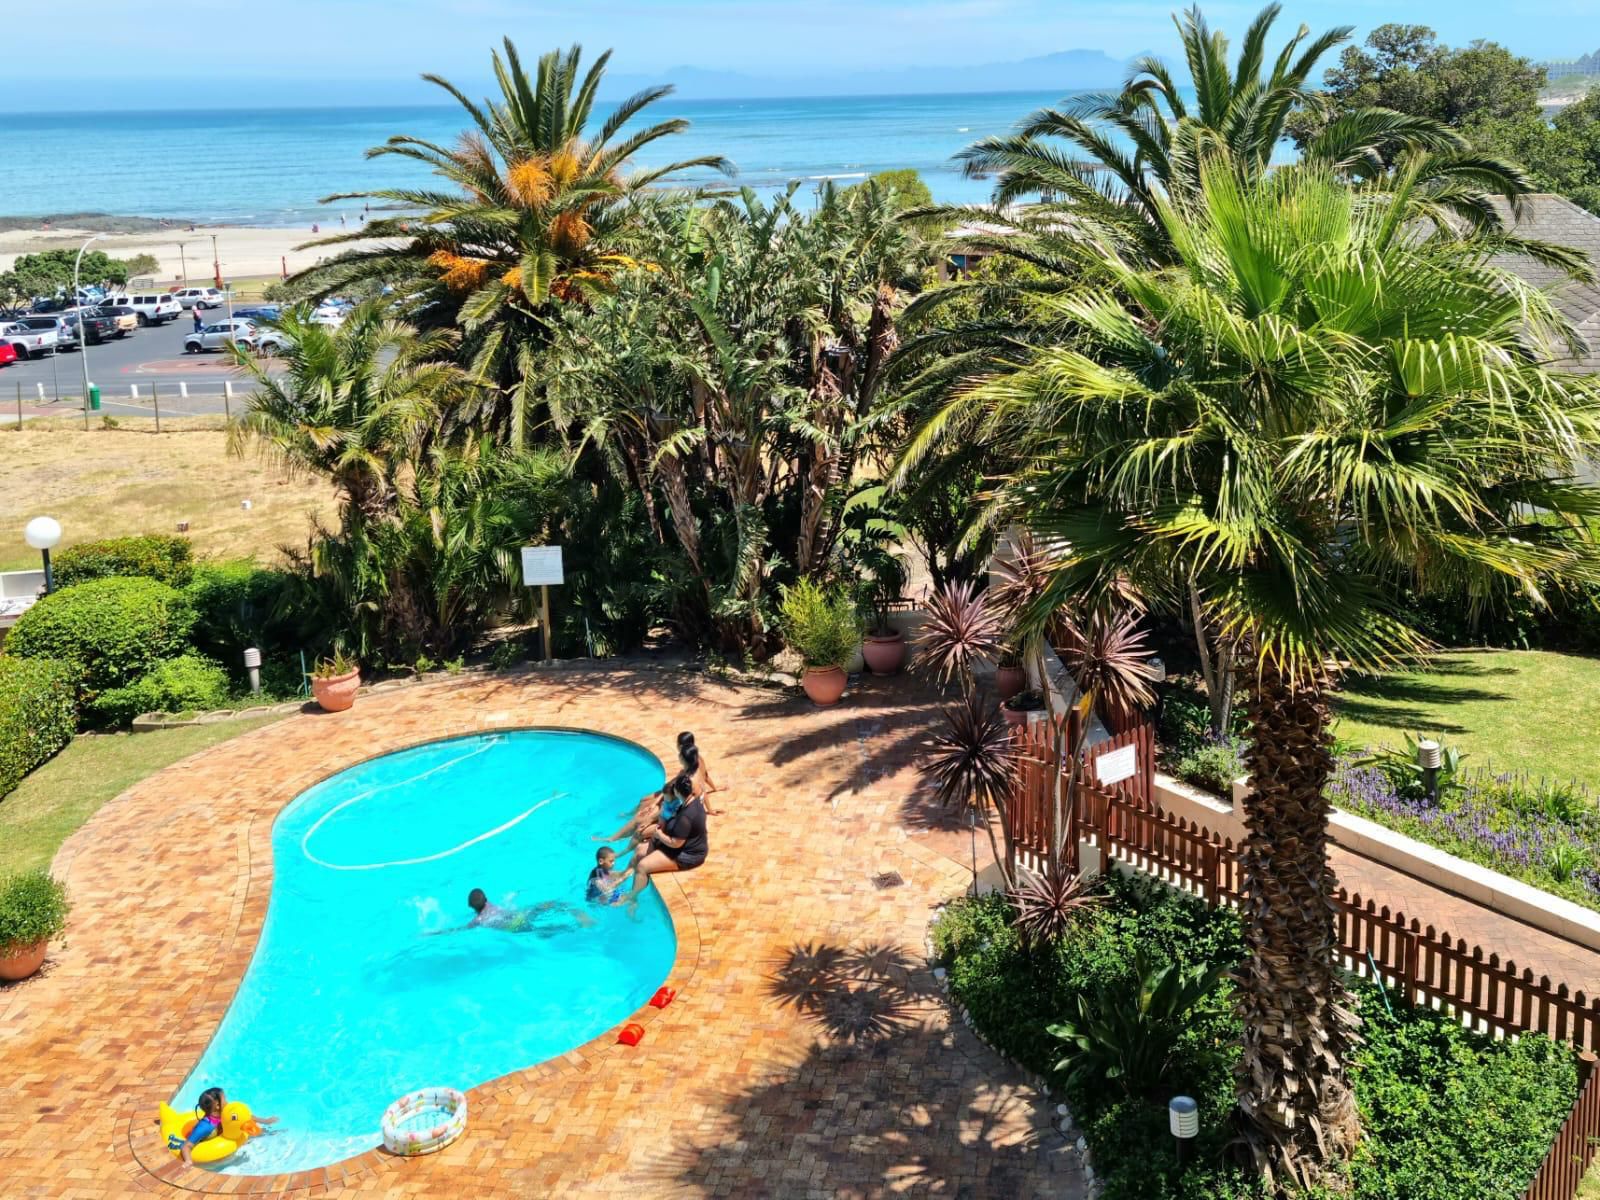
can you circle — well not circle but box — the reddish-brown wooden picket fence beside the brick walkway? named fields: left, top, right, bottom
left=1010, top=722, right=1600, bottom=1200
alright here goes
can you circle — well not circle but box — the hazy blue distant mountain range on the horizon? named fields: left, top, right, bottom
left=600, top=50, right=1128, bottom=99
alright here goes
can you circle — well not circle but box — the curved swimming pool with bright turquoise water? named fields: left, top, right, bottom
left=171, top=730, right=677, bottom=1174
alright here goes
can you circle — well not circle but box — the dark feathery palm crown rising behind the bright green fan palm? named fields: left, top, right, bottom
left=958, top=3, right=1531, bottom=261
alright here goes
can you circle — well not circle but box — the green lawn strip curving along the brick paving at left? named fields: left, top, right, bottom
left=0, top=717, right=280, bottom=875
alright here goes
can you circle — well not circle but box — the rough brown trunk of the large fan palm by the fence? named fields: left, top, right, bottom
left=1235, top=664, right=1358, bottom=1182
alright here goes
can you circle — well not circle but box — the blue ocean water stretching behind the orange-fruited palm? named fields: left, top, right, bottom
left=0, top=93, right=1061, bottom=226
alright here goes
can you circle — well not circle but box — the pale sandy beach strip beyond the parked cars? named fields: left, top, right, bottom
left=0, top=218, right=395, bottom=283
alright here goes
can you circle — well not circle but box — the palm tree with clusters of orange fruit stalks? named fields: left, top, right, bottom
left=301, top=38, right=731, bottom=445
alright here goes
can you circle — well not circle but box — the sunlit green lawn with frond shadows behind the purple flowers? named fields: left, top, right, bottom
left=1334, top=650, right=1600, bottom=790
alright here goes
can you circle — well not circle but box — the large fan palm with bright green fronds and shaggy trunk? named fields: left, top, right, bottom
left=921, top=162, right=1600, bottom=1181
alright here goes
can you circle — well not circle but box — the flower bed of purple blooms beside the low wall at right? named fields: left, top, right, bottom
left=1328, top=760, right=1600, bottom=910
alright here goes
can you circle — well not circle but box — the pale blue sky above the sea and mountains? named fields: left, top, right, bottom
left=0, top=0, right=1600, bottom=107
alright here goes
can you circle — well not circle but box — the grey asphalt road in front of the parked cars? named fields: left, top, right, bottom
left=0, top=309, right=273, bottom=421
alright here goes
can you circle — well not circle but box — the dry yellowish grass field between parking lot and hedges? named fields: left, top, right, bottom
left=0, top=416, right=333, bottom=571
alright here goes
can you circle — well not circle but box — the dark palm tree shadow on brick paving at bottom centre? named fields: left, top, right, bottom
left=646, top=942, right=1083, bottom=1200
